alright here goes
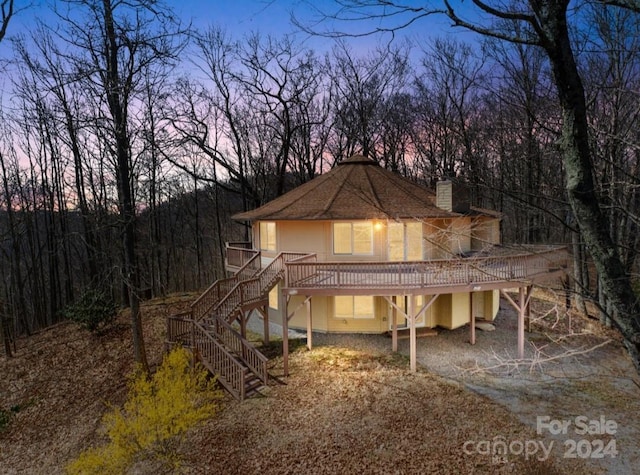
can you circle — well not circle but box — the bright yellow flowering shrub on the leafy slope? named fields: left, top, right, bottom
left=67, top=348, right=221, bottom=474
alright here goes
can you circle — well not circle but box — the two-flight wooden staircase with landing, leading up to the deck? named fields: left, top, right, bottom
left=166, top=251, right=300, bottom=400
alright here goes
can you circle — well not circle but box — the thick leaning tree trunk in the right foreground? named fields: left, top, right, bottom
left=532, top=0, right=640, bottom=371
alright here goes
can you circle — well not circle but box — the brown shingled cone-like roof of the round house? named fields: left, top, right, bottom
left=233, top=155, right=490, bottom=221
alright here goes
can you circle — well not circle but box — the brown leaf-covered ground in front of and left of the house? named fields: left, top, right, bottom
left=0, top=295, right=635, bottom=474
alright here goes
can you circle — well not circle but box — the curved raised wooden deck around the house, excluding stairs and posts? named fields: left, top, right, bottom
left=227, top=246, right=568, bottom=295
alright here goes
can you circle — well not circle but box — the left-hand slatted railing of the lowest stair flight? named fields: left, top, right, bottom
left=193, top=322, right=245, bottom=401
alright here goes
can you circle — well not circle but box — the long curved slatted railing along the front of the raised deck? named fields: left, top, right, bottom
left=285, top=248, right=566, bottom=289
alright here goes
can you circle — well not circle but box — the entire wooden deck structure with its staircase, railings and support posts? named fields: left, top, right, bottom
left=167, top=243, right=568, bottom=400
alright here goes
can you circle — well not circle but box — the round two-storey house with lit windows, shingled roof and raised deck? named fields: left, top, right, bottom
left=169, top=155, right=565, bottom=400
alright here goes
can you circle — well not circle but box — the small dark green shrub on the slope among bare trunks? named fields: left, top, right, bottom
left=64, top=289, right=118, bottom=332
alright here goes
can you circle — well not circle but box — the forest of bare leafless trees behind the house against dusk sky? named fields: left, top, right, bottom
left=0, top=0, right=640, bottom=364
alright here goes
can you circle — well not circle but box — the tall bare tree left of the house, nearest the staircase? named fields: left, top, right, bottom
left=50, top=0, right=183, bottom=369
